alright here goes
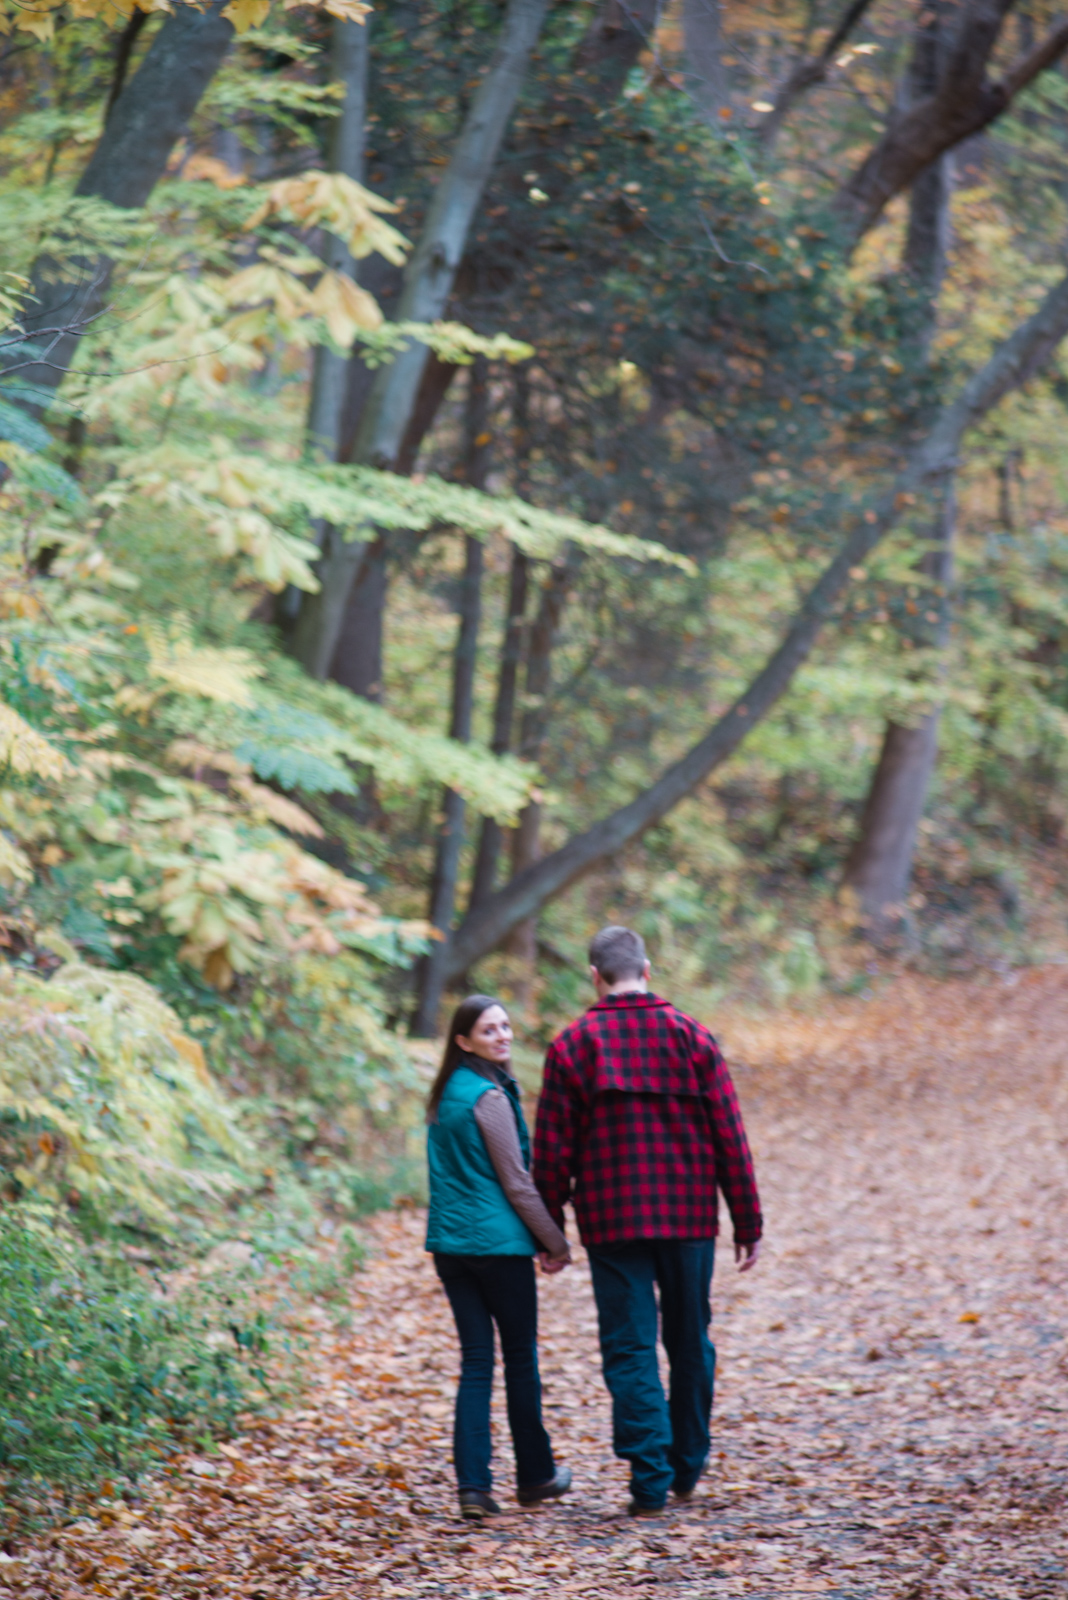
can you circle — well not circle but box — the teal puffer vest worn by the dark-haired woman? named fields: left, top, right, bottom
left=427, top=1066, right=537, bottom=1256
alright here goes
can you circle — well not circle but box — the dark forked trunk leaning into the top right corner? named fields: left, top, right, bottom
left=835, top=0, right=1068, bottom=242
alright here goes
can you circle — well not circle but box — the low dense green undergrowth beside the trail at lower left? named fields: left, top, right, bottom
left=0, top=1206, right=269, bottom=1528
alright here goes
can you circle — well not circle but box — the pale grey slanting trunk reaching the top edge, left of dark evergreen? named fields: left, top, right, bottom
left=294, top=0, right=548, bottom=678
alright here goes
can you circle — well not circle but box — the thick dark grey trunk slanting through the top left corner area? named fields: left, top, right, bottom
left=12, top=0, right=233, bottom=411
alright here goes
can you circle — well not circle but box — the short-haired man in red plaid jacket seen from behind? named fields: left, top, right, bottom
left=531, top=926, right=763, bottom=1517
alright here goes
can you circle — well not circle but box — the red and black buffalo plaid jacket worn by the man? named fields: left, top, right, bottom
left=531, top=994, right=763, bottom=1245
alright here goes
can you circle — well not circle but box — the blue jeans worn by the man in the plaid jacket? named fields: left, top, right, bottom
left=587, top=1238, right=716, bottom=1506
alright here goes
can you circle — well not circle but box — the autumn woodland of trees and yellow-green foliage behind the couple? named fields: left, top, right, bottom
left=0, top=0, right=1068, bottom=1518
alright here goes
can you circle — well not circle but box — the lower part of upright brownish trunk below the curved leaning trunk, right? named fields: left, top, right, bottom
left=843, top=482, right=956, bottom=944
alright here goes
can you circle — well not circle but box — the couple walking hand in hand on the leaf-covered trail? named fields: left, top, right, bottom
left=427, top=926, right=761, bottom=1520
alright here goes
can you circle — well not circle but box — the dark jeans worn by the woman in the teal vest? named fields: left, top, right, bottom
left=433, top=1254, right=556, bottom=1493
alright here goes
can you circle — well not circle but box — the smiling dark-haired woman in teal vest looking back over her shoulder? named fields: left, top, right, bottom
left=427, top=995, right=571, bottom=1522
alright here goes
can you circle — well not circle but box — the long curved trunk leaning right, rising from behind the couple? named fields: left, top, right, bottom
left=448, top=257, right=1068, bottom=978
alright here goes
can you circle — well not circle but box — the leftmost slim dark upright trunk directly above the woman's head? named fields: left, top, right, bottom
left=412, top=357, right=489, bottom=1038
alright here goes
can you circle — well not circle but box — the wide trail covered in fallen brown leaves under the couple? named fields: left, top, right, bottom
left=8, top=968, right=1068, bottom=1600
